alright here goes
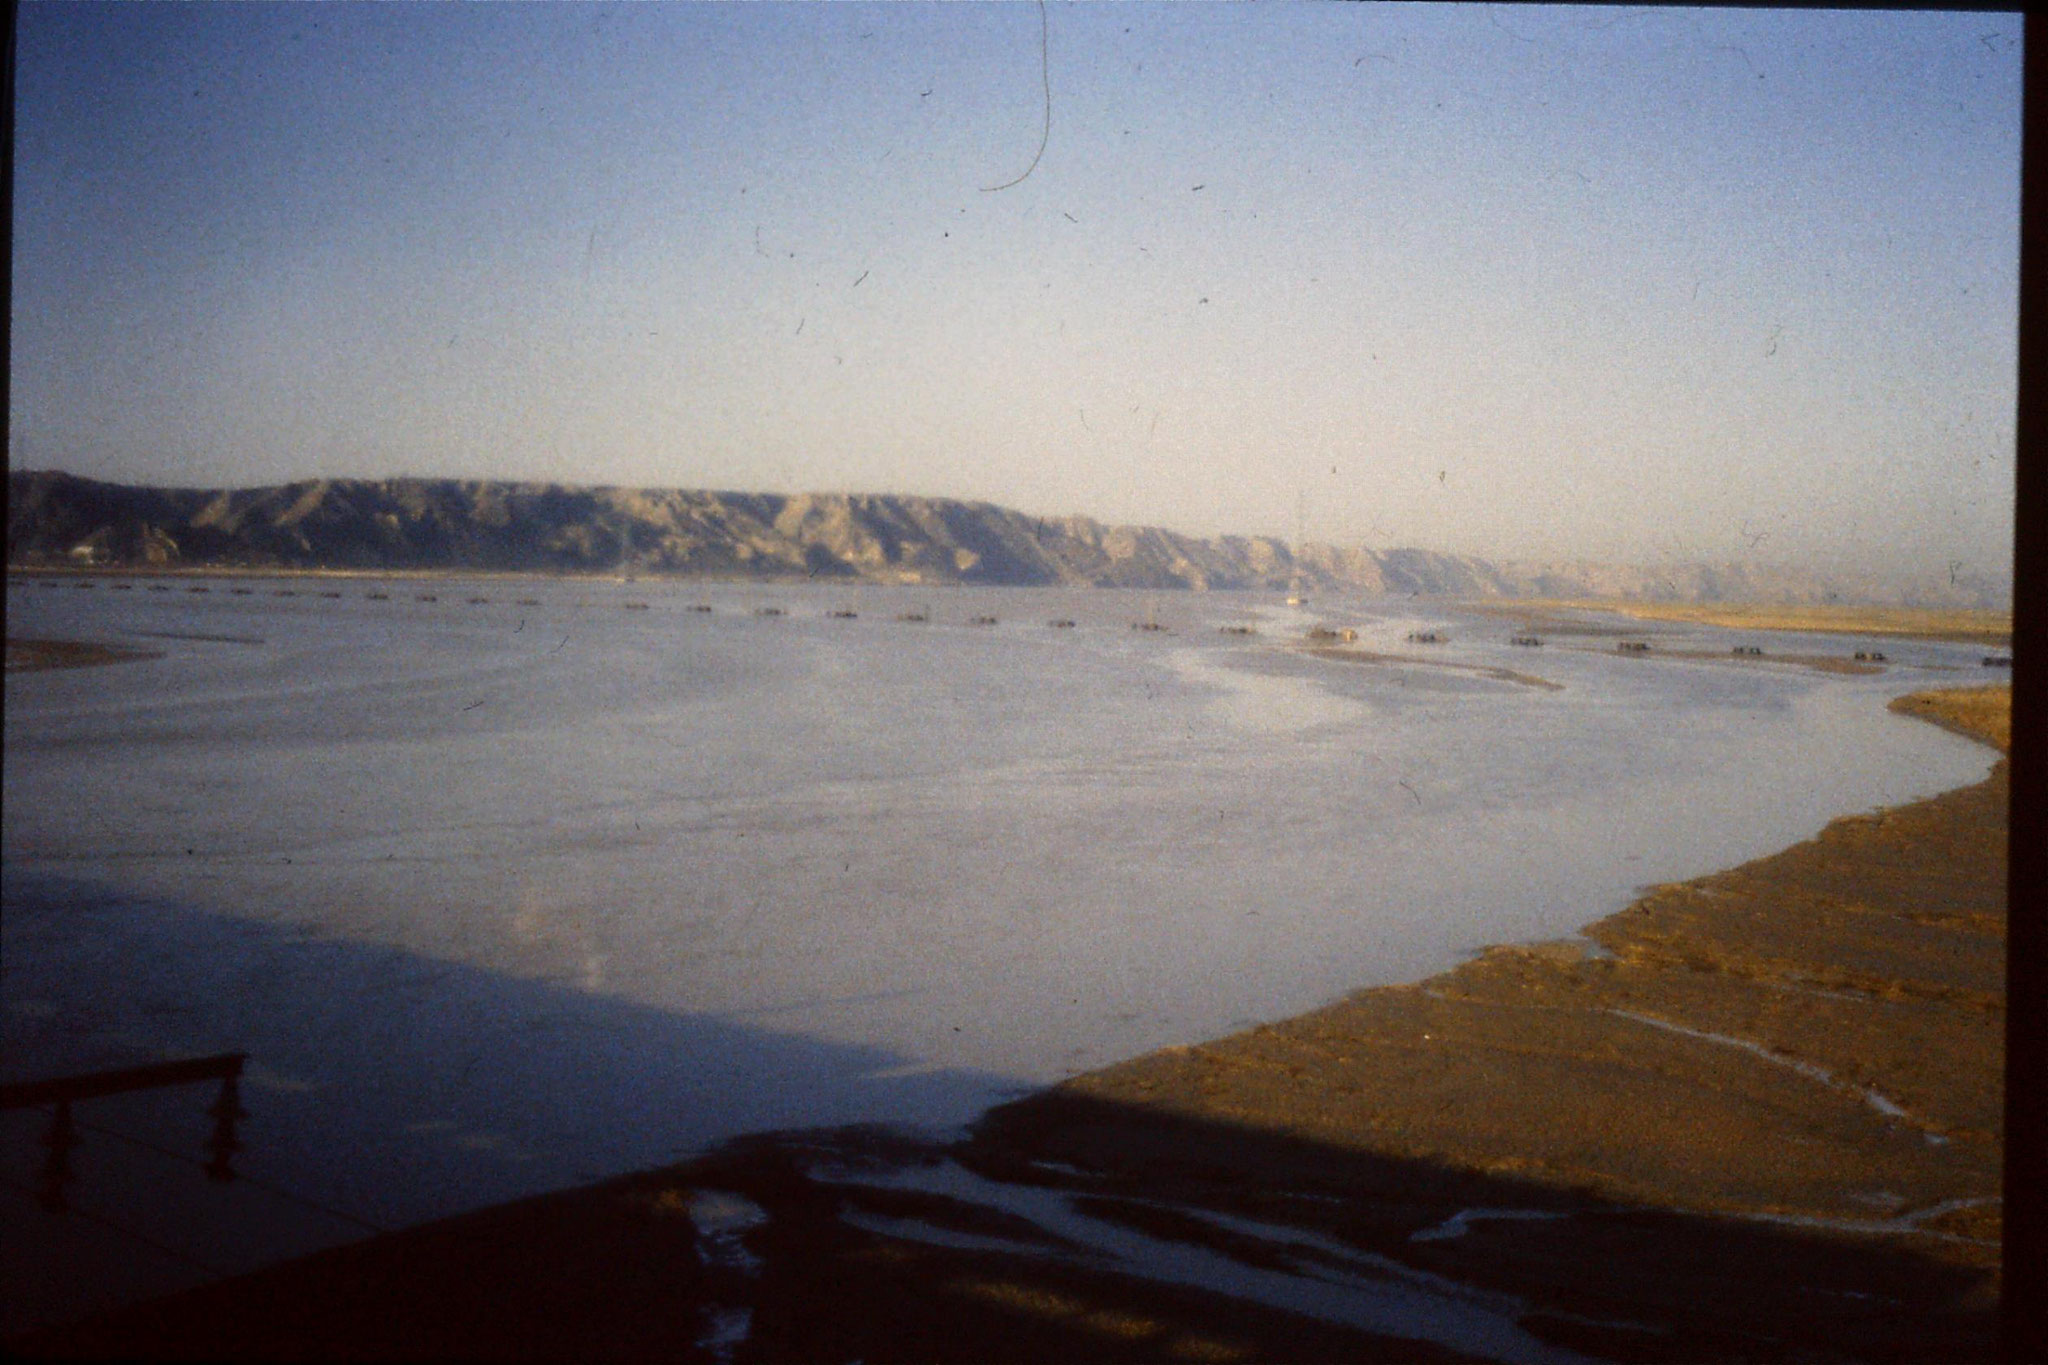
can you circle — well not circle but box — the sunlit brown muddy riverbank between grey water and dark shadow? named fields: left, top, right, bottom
left=1010, top=774, right=2003, bottom=1265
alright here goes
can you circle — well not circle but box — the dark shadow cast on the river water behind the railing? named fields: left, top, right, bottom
left=0, top=871, right=1022, bottom=1355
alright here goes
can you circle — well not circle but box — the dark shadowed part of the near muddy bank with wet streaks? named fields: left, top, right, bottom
left=8, top=1093, right=1995, bottom=1363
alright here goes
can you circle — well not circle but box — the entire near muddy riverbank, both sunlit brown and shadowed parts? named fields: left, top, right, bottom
left=8, top=688, right=2009, bottom=1361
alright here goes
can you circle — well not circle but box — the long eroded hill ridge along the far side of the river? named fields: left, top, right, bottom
left=6, top=471, right=2009, bottom=606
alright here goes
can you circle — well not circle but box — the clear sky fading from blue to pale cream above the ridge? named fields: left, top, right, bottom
left=8, top=0, right=2021, bottom=577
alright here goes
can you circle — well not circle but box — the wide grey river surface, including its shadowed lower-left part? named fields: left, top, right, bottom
left=0, top=577, right=1993, bottom=1334
